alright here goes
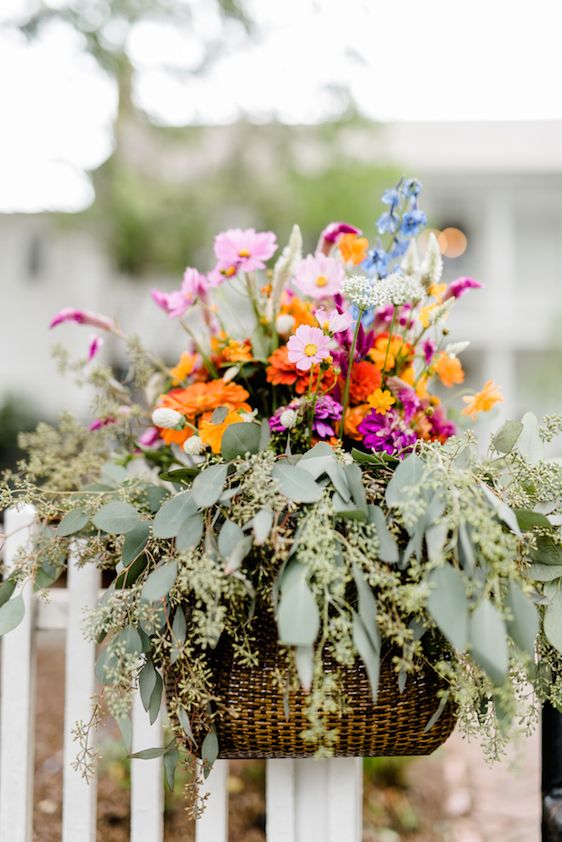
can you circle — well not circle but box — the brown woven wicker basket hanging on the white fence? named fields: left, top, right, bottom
left=166, top=617, right=456, bottom=759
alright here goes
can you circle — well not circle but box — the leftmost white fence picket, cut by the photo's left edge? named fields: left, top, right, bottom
left=0, top=506, right=35, bottom=842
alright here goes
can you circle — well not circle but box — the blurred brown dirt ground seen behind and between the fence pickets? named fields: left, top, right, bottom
left=29, top=632, right=540, bottom=842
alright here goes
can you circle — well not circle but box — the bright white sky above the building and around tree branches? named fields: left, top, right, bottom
left=0, top=0, right=562, bottom=211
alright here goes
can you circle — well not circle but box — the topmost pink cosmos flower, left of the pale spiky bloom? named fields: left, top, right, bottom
left=214, top=228, right=277, bottom=278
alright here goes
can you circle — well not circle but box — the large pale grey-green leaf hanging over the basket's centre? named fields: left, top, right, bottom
left=277, top=561, right=320, bottom=646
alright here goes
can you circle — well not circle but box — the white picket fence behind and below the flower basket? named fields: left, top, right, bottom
left=0, top=507, right=363, bottom=842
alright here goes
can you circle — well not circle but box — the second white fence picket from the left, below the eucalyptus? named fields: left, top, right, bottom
left=62, top=554, right=101, bottom=842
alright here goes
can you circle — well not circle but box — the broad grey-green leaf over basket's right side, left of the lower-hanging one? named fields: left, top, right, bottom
left=427, top=565, right=468, bottom=652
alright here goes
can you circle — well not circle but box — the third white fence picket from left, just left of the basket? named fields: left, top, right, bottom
left=131, top=692, right=164, bottom=842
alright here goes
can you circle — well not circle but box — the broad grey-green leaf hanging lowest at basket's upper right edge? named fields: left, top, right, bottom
left=470, top=599, right=509, bottom=687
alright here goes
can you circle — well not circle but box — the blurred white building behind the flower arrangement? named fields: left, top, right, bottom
left=0, top=122, right=562, bottom=426
